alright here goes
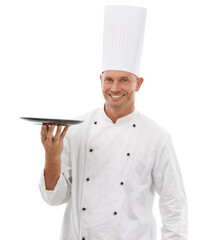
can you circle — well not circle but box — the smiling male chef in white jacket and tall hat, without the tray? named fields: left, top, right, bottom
left=39, top=5, right=188, bottom=240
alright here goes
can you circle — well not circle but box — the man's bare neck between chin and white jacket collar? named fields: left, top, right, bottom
left=104, top=104, right=135, bottom=123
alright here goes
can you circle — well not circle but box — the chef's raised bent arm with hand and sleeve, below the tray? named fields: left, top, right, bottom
left=39, top=126, right=71, bottom=205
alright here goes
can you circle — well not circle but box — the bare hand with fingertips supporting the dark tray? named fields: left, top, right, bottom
left=41, top=124, right=69, bottom=161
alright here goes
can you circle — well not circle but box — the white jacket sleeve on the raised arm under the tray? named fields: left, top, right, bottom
left=39, top=129, right=72, bottom=206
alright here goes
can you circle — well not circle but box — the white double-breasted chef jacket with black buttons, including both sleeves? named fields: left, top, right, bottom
left=39, top=107, right=187, bottom=240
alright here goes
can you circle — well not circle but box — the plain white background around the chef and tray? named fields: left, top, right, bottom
left=0, top=0, right=204, bottom=240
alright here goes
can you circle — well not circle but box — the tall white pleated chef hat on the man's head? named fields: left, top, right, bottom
left=102, top=5, right=146, bottom=76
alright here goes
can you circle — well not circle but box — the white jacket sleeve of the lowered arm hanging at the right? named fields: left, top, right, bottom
left=152, top=133, right=188, bottom=240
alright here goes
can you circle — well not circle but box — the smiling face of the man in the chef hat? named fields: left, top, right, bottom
left=100, top=70, right=143, bottom=111
